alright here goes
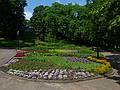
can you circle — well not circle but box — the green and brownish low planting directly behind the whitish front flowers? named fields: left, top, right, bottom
left=9, top=56, right=101, bottom=71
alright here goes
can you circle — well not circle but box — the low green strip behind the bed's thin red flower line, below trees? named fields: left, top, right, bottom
left=22, top=41, right=91, bottom=51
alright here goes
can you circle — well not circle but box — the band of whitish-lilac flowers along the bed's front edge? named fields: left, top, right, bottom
left=7, top=69, right=99, bottom=80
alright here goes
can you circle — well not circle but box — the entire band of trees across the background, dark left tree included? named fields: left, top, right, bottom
left=0, top=0, right=120, bottom=50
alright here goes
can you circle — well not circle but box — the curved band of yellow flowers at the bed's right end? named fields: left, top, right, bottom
left=88, top=56, right=111, bottom=74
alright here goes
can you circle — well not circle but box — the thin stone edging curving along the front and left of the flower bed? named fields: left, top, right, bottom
left=0, top=56, right=103, bottom=83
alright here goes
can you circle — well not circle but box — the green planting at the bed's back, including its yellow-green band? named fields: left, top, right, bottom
left=22, top=40, right=94, bottom=54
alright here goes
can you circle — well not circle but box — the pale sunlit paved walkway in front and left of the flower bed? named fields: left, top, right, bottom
left=0, top=49, right=120, bottom=90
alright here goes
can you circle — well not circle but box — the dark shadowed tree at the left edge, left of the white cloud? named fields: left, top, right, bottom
left=0, top=0, right=26, bottom=39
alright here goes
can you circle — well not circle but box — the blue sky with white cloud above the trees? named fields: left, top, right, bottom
left=24, top=0, right=86, bottom=20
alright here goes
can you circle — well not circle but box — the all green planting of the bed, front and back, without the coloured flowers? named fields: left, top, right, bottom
left=5, top=42, right=101, bottom=72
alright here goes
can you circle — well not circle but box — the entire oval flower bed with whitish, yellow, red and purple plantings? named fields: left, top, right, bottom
left=2, top=42, right=111, bottom=80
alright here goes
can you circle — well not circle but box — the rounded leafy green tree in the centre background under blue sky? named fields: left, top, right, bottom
left=31, top=3, right=82, bottom=42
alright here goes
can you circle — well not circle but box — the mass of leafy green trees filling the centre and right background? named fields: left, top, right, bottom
left=31, top=0, right=120, bottom=48
